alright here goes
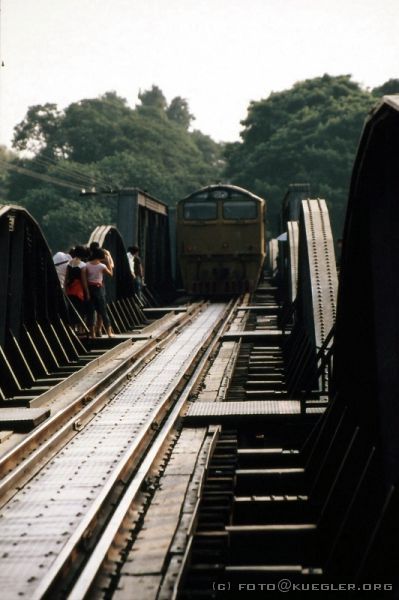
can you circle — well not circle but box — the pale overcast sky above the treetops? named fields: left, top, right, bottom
left=0, top=0, right=399, bottom=146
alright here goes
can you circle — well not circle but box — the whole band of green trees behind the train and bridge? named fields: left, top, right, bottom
left=0, top=75, right=399, bottom=250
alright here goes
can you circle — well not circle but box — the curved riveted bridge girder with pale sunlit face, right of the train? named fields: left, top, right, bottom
left=286, top=199, right=338, bottom=397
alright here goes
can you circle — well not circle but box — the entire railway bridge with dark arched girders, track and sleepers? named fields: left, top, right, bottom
left=0, top=97, right=399, bottom=600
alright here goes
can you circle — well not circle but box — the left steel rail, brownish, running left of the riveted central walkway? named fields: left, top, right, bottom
left=0, top=304, right=201, bottom=505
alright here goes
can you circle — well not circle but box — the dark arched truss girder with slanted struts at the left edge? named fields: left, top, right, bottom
left=0, top=206, right=86, bottom=406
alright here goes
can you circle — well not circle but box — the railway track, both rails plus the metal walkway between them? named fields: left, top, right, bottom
left=0, top=304, right=238, bottom=600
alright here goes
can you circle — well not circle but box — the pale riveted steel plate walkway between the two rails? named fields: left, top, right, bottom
left=0, top=304, right=225, bottom=598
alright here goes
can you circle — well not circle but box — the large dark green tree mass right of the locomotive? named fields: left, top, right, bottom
left=226, top=75, right=399, bottom=235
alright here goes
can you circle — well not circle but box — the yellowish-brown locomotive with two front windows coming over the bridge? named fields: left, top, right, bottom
left=176, top=184, right=266, bottom=296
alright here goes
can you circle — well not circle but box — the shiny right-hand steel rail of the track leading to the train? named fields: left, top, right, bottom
left=68, top=299, right=239, bottom=600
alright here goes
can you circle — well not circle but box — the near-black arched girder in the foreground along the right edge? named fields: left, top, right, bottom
left=333, top=96, right=399, bottom=484
